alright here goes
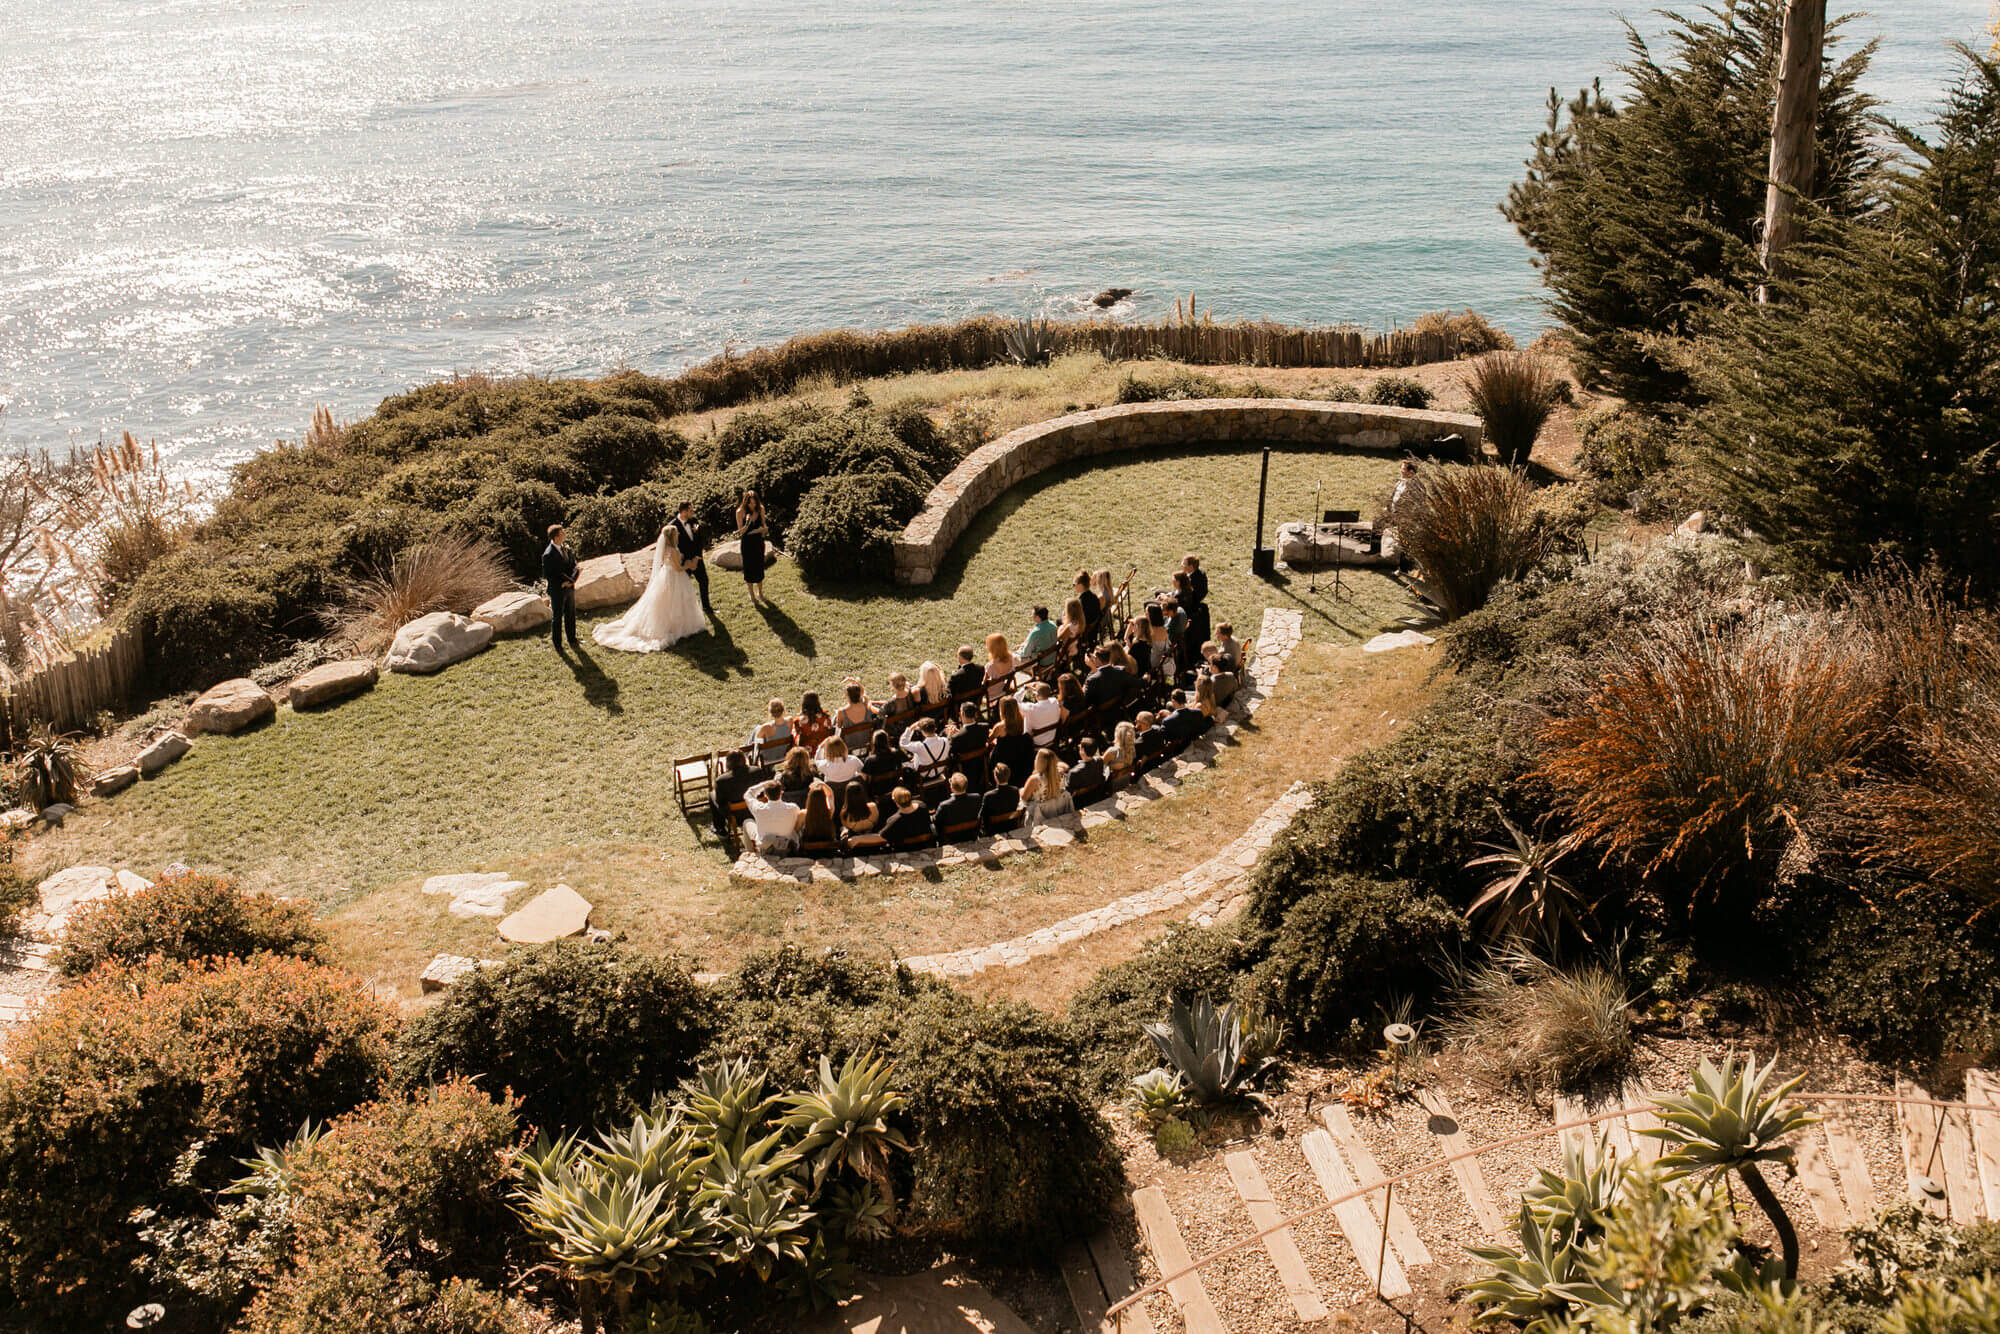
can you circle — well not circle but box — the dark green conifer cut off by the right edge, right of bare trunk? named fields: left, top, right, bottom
left=1688, top=48, right=2000, bottom=592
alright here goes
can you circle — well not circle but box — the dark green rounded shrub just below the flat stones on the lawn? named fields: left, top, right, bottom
left=396, top=940, right=720, bottom=1136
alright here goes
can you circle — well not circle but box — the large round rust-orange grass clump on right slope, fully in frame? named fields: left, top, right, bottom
left=1536, top=612, right=1882, bottom=910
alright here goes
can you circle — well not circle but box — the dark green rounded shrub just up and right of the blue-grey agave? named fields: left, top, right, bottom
left=1254, top=876, right=1466, bottom=1046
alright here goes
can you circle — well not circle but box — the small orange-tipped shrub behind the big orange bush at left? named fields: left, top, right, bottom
left=56, top=872, right=326, bottom=978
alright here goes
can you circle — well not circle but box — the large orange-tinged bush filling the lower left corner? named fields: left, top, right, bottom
left=0, top=956, right=394, bottom=1328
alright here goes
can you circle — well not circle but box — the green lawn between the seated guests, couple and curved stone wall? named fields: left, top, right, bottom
left=52, top=446, right=1408, bottom=980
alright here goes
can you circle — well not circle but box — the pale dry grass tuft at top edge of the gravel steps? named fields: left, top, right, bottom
left=1444, top=950, right=1632, bottom=1094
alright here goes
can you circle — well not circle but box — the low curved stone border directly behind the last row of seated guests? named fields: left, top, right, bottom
left=730, top=608, right=1304, bottom=884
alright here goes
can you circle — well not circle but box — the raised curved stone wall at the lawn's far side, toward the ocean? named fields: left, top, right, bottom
left=896, top=398, right=1482, bottom=584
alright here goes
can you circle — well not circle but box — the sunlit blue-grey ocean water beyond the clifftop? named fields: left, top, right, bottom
left=0, top=0, right=1988, bottom=474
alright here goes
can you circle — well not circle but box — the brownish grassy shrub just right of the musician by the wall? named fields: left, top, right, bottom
left=1388, top=464, right=1550, bottom=620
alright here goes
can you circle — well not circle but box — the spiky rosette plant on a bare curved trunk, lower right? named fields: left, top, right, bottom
left=1640, top=1056, right=1818, bottom=1282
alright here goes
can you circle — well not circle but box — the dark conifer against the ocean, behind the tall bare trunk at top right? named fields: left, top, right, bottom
left=1500, top=0, right=1880, bottom=404
